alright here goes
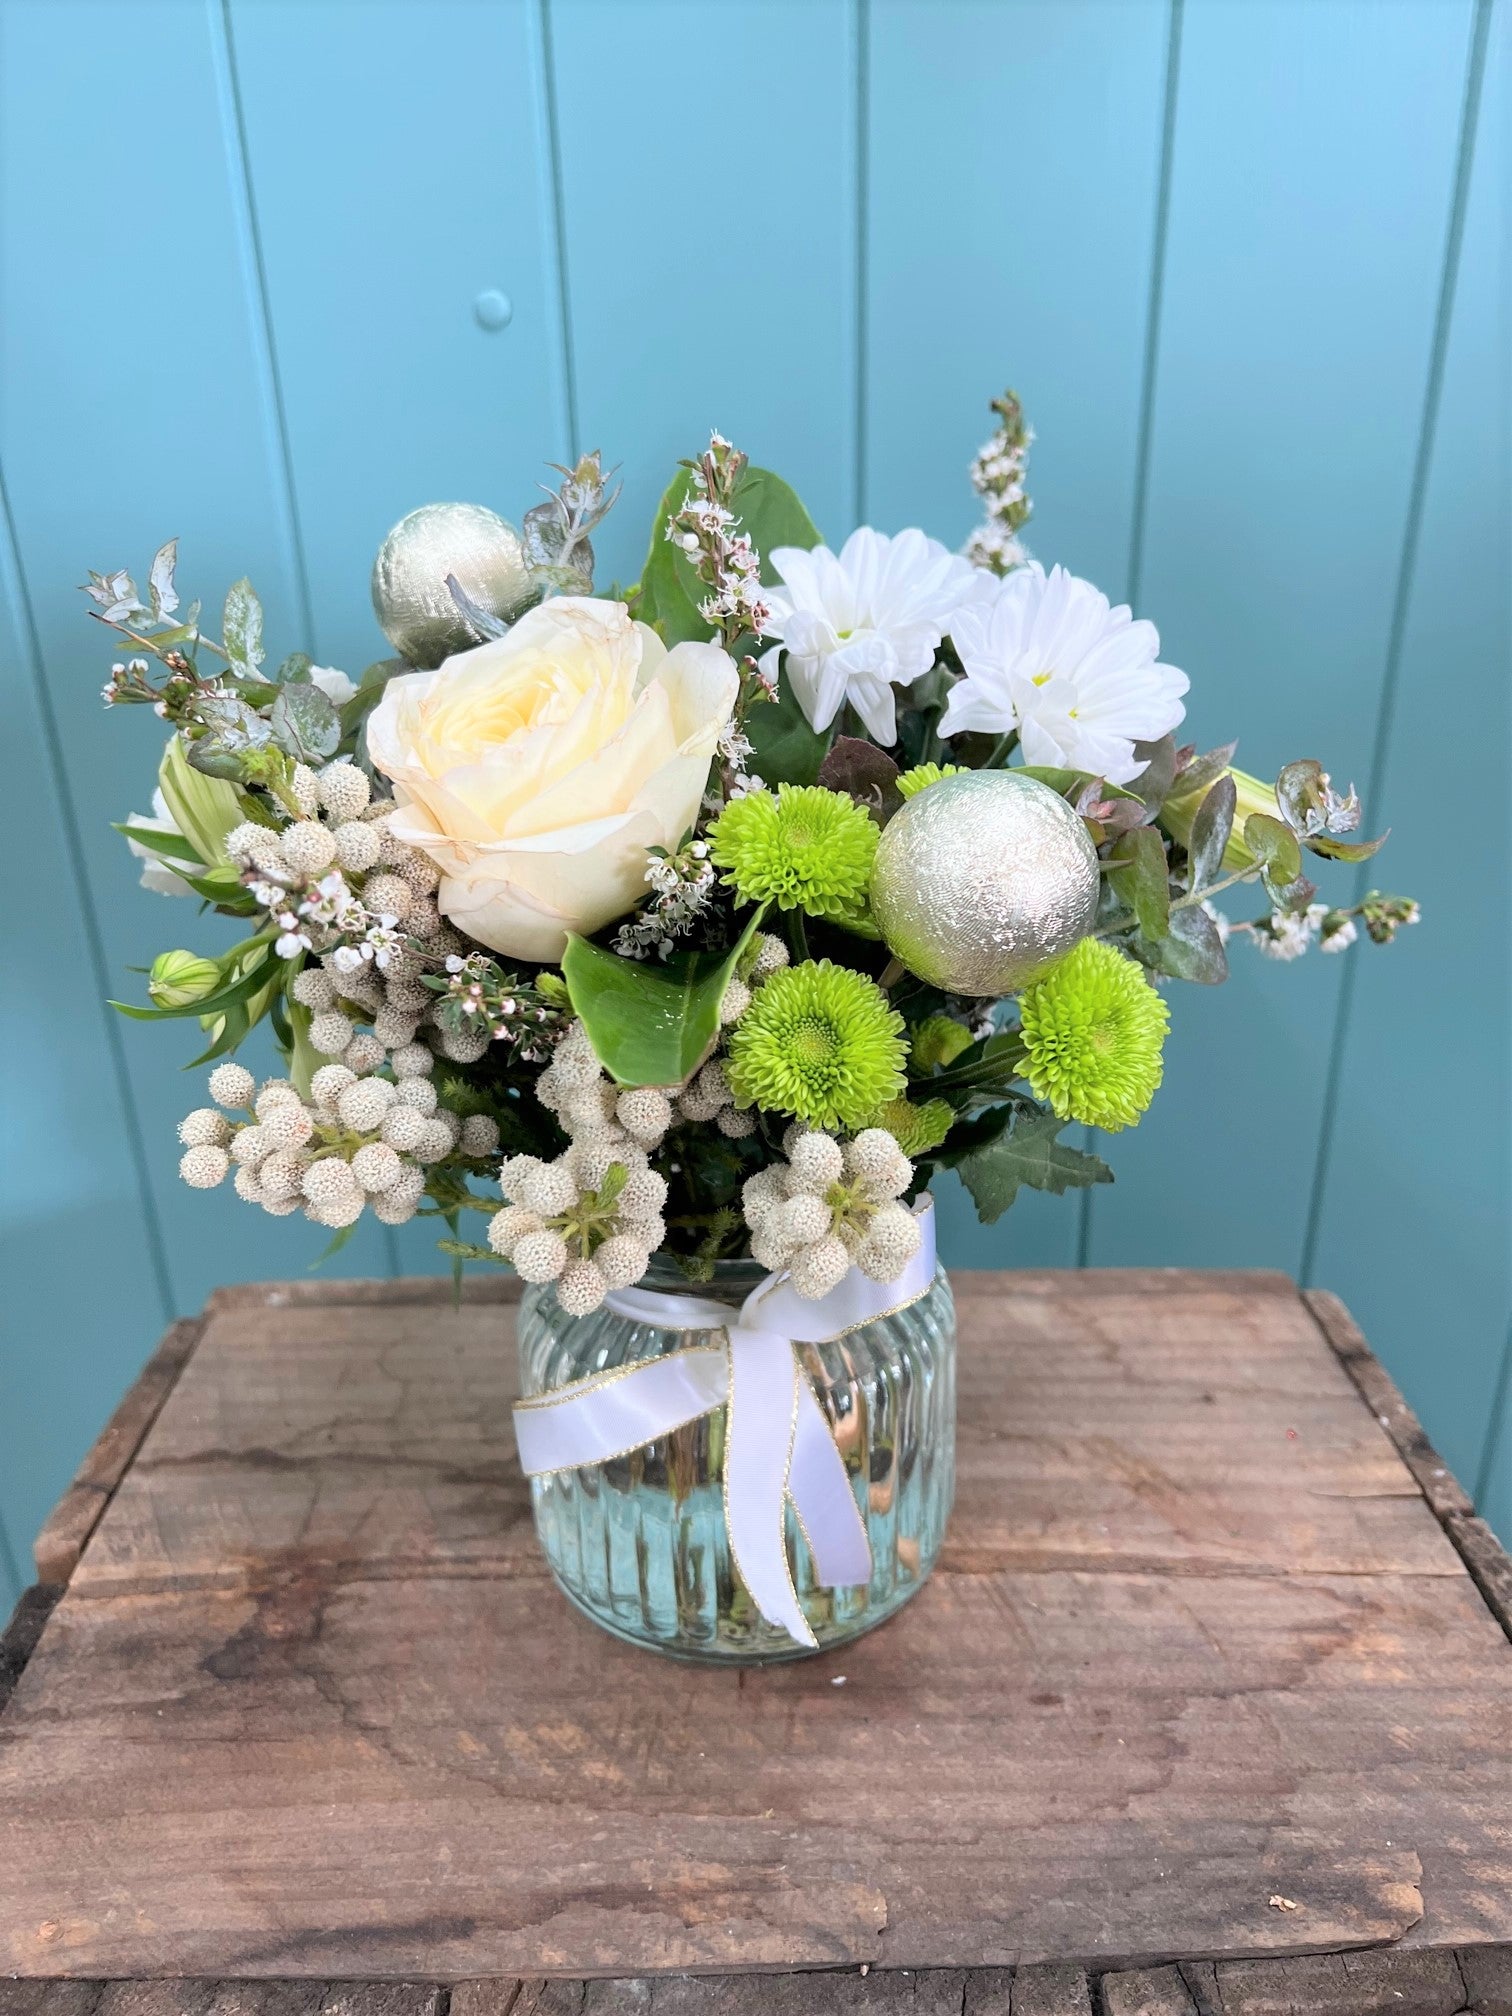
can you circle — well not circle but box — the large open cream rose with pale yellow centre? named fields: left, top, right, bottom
left=367, top=595, right=740, bottom=960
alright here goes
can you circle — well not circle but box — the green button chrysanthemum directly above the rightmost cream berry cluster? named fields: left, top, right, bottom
left=726, top=960, right=907, bottom=1131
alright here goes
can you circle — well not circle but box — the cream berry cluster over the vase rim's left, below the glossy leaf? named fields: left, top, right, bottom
left=488, top=1022, right=673, bottom=1316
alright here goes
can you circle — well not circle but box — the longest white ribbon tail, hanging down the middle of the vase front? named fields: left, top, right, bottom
left=724, top=1327, right=822, bottom=1647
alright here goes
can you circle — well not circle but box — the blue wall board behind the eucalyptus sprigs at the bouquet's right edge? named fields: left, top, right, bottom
left=1091, top=0, right=1470, bottom=1270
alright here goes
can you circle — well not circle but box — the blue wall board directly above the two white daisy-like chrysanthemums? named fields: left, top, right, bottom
left=863, top=0, right=1169, bottom=1266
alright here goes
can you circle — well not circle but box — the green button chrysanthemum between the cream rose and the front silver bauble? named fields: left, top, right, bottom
left=710, top=784, right=877, bottom=923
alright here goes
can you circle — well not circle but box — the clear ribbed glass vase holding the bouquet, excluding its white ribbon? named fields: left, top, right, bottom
left=520, top=1256, right=956, bottom=1665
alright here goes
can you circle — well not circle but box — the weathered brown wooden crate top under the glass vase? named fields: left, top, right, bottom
left=0, top=1272, right=1512, bottom=2016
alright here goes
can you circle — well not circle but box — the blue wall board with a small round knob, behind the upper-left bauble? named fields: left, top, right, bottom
left=230, top=0, right=569, bottom=1272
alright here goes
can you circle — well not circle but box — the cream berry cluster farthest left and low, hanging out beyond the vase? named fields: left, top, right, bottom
left=179, top=1038, right=498, bottom=1228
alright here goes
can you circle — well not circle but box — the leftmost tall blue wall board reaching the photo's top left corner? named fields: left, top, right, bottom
left=0, top=0, right=397, bottom=1546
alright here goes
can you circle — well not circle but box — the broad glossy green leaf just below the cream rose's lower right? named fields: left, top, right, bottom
left=562, top=909, right=764, bottom=1085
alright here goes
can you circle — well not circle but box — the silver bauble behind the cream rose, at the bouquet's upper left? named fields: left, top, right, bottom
left=373, top=504, right=538, bottom=669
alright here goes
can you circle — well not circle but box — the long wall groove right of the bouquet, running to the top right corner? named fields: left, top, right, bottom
left=1298, top=0, right=1492, bottom=1286
